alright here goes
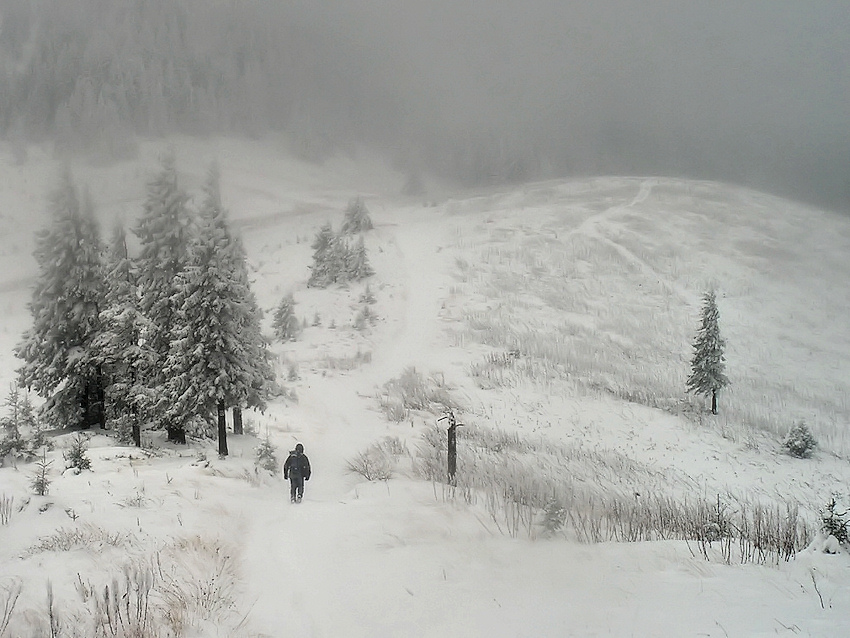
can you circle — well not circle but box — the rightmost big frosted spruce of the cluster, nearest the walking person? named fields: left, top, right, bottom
left=160, top=166, right=274, bottom=456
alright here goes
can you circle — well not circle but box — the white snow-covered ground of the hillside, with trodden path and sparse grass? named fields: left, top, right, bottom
left=0, top=138, right=850, bottom=638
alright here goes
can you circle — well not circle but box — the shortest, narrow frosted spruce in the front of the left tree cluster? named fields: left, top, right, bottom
left=95, top=224, right=155, bottom=447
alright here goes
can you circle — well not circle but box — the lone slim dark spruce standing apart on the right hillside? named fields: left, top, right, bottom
left=687, top=291, right=729, bottom=414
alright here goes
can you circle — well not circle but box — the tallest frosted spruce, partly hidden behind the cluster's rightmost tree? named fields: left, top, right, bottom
left=134, top=154, right=194, bottom=442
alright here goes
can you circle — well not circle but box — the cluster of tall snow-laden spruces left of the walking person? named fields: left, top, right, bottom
left=15, top=155, right=275, bottom=454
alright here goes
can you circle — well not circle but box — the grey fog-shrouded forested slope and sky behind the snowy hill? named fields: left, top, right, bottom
left=0, top=0, right=850, bottom=210
